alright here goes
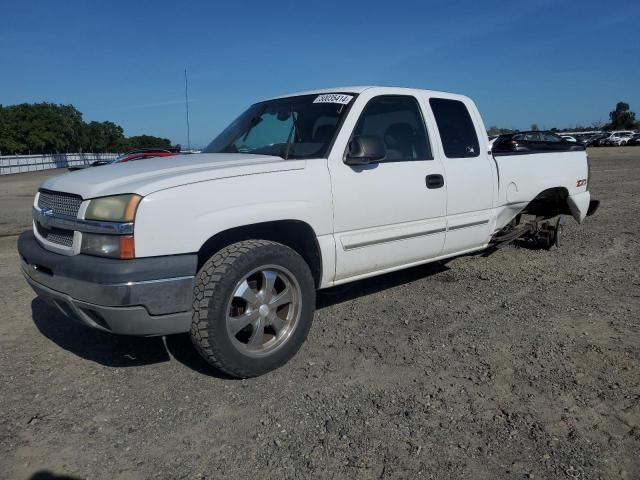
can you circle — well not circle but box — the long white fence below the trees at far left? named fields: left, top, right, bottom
left=0, top=153, right=118, bottom=175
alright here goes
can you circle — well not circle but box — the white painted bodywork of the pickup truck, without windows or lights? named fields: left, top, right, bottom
left=37, top=87, right=589, bottom=288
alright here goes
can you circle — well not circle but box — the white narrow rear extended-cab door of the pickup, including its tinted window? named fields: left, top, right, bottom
left=429, top=95, right=497, bottom=254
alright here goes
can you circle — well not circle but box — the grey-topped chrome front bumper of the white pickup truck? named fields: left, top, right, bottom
left=18, top=232, right=196, bottom=336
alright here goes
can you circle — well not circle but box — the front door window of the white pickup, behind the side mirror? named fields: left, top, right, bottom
left=353, top=95, right=433, bottom=162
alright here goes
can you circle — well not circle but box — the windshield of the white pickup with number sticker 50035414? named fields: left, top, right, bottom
left=203, top=93, right=355, bottom=159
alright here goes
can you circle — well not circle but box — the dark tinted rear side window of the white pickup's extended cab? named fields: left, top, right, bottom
left=429, top=98, right=480, bottom=158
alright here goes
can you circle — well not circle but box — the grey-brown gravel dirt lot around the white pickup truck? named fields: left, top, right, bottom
left=0, top=147, right=640, bottom=479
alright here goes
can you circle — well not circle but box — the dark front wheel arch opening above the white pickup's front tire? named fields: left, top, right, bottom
left=198, top=220, right=322, bottom=288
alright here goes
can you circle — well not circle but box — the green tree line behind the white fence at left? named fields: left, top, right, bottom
left=0, top=103, right=176, bottom=155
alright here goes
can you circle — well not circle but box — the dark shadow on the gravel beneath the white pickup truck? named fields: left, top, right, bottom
left=31, top=262, right=448, bottom=379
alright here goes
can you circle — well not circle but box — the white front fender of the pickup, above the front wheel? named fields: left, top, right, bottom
left=134, top=159, right=333, bottom=257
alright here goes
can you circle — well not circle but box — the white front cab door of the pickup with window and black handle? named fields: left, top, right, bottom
left=329, top=91, right=447, bottom=283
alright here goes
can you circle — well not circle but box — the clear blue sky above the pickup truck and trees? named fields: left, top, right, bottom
left=0, top=0, right=640, bottom=146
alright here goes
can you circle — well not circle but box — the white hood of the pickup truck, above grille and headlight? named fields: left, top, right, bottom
left=42, top=153, right=305, bottom=199
